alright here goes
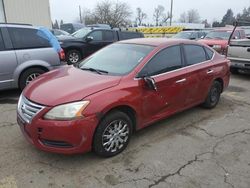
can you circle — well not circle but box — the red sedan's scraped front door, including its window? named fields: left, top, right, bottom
left=139, top=45, right=187, bottom=123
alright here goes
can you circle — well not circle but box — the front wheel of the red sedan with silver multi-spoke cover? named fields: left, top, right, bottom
left=93, top=111, right=133, bottom=157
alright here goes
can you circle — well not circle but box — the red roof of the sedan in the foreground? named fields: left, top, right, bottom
left=118, top=38, right=203, bottom=47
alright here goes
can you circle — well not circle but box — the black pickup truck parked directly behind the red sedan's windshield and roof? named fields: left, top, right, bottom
left=59, top=27, right=144, bottom=64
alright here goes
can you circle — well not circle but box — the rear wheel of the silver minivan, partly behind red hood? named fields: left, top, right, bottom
left=19, top=68, right=46, bottom=90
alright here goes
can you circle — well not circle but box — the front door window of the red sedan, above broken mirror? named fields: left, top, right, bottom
left=142, top=46, right=182, bottom=76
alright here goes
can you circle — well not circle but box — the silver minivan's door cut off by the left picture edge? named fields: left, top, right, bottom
left=0, top=28, right=17, bottom=89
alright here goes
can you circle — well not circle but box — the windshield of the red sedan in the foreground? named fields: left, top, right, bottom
left=79, top=44, right=154, bottom=76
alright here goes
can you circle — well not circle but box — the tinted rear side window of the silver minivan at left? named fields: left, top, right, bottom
left=8, top=28, right=51, bottom=49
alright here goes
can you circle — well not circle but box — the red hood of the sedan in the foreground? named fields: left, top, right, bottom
left=23, top=66, right=121, bottom=106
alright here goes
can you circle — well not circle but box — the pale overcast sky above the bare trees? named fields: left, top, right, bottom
left=50, top=0, right=250, bottom=22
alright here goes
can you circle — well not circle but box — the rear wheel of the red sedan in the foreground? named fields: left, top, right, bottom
left=202, top=81, right=222, bottom=109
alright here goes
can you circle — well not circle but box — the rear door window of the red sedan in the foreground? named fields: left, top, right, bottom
left=184, top=45, right=207, bottom=65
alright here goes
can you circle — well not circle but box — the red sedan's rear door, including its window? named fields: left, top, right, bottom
left=183, top=44, right=214, bottom=108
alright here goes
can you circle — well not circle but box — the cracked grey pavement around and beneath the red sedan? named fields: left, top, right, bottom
left=0, top=75, right=250, bottom=188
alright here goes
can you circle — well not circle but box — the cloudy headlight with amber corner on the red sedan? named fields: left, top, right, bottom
left=44, top=101, right=89, bottom=121
